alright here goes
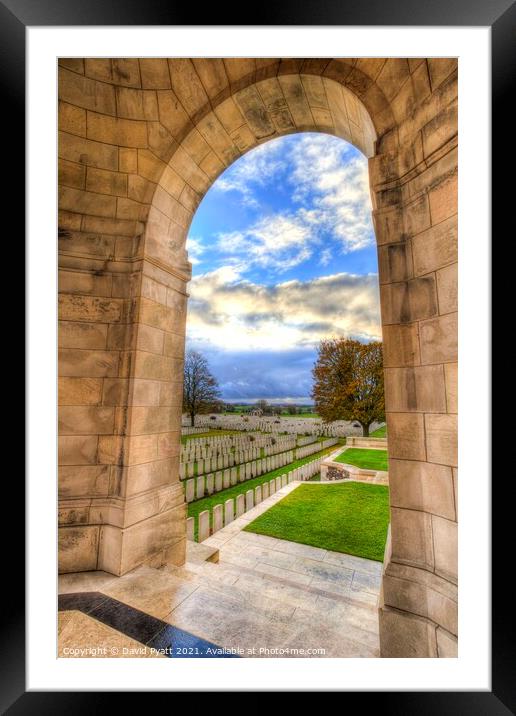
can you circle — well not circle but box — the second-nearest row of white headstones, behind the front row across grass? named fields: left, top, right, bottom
left=185, top=450, right=294, bottom=502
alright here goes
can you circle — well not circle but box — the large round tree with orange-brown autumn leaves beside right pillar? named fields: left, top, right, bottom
left=312, top=338, right=385, bottom=437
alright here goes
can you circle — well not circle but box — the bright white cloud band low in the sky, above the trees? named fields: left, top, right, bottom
left=188, top=266, right=381, bottom=351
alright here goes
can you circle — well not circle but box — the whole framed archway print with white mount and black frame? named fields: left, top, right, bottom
left=8, top=2, right=515, bottom=714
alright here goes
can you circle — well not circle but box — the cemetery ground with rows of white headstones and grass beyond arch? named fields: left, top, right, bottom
left=180, top=416, right=387, bottom=544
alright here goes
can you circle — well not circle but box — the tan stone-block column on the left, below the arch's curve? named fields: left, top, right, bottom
left=59, top=215, right=189, bottom=575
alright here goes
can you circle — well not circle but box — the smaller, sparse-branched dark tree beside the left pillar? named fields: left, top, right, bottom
left=183, top=350, right=220, bottom=426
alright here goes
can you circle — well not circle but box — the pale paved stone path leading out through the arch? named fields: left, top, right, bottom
left=60, top=483, right=382, bottom=657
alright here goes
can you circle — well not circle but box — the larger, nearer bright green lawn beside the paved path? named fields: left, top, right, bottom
left=244, top=482, right=389, bottom=562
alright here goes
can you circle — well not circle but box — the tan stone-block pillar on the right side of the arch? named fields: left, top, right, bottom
left=370, top=60, right=457, bottom=657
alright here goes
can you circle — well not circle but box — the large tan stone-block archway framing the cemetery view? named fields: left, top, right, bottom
left=59, top=58, right=457, bottom=656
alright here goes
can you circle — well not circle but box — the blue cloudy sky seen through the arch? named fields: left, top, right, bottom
left=187, top=133, right=381, bottom=402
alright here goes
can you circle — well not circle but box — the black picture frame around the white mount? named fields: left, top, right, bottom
left=10, top=0, right=510, bottom=716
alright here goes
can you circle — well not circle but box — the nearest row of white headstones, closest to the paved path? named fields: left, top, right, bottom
left=186, top=458, right=322, bottom=542
